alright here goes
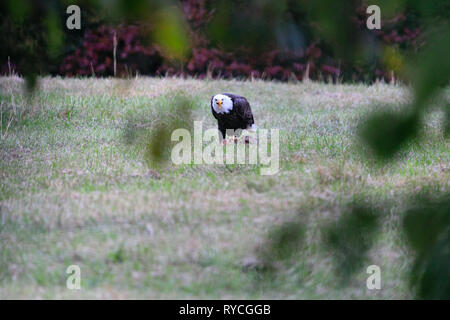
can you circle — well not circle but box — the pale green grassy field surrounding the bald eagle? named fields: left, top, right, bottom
left=0, top=78, right=450, bottom=299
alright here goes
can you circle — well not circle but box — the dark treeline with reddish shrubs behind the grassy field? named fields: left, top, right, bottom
left=0, top=0, right=440, bottom=82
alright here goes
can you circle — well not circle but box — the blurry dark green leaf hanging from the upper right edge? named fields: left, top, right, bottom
left=360, top=5, right=450, bottom=160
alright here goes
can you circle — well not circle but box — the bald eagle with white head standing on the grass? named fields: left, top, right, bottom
left=211, top=93, right=256, bottom=142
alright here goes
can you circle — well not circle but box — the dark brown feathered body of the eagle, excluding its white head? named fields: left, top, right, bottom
left=211, top=93, right=255, bottom=138
